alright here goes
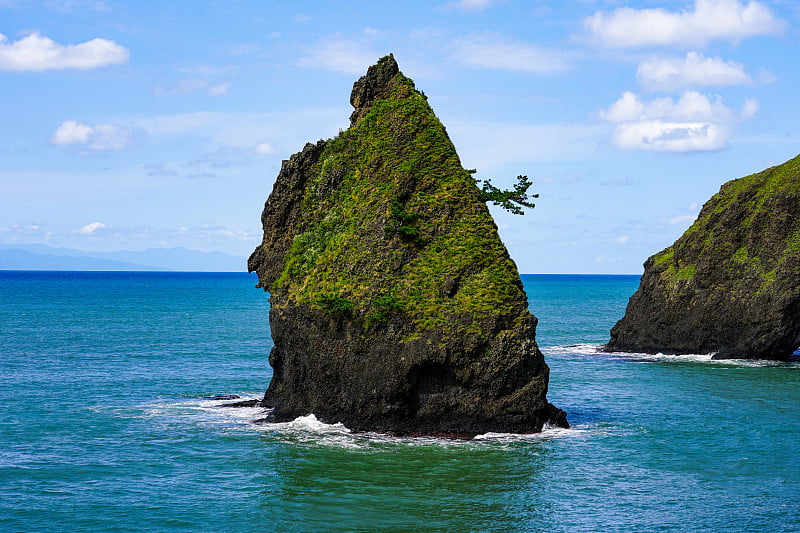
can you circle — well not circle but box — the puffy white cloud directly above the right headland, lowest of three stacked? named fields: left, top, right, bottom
left=600, top=91, right=756, bottom=152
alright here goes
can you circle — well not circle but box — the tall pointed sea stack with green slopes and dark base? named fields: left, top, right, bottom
left=248, top=55, right=567, bottom=438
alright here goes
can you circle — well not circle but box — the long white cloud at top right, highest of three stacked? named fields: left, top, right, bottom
left=583, top=0, right=785, bottom=48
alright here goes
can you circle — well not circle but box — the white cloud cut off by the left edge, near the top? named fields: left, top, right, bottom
left=0, top=33, right=130, bottom=72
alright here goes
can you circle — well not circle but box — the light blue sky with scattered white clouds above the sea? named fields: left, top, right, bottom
left=0, top=0, right=800, bottom=274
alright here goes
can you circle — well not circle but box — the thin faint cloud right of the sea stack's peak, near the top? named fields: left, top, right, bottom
left=454, top=35, right=570, bottom=74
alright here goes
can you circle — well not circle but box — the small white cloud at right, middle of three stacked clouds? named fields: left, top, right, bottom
left=636, top=52, right=753, bottom=90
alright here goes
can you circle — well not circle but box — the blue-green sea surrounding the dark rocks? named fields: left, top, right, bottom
left=0, top=272, right=800, bottom=533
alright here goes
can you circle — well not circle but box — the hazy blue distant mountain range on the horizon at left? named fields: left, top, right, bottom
left=0, top=244, right=247, bottom=272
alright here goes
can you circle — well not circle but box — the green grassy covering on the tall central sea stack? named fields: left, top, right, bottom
left=276, top=68, right=525, bottom=333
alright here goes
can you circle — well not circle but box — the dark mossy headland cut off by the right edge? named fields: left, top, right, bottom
left=607, top=156, right=800, bottom=360
